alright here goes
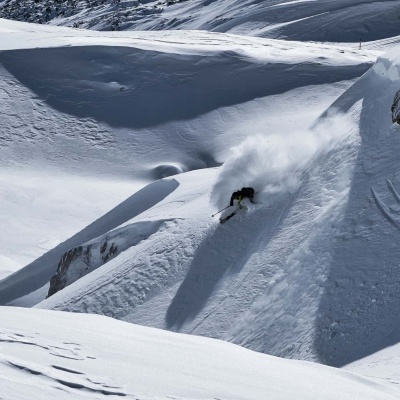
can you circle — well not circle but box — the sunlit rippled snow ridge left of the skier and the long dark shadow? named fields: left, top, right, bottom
left=35, top=170, right=215, bottom=319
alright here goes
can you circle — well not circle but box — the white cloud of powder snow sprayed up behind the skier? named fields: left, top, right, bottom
left=211, top=114, right=354, bottom=209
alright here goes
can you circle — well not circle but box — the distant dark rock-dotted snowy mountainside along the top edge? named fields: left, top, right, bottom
left=0, top=0, right=400, bottom=42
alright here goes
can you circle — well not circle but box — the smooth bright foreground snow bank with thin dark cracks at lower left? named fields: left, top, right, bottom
left=0, top=307, right=399, bottom=400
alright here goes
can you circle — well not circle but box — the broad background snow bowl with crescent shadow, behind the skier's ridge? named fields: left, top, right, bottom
left=0, top=20, right=380, bottom=282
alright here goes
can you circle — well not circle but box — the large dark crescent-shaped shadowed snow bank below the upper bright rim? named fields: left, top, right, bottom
left=0, top=43, right=374, bottom=129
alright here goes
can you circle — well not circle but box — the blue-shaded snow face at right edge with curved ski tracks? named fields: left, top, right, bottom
left=315, top=48, right=400, bottom=365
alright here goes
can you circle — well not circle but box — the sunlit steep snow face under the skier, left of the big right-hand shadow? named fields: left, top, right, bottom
left=34, top=107, right=359, bottom=366
